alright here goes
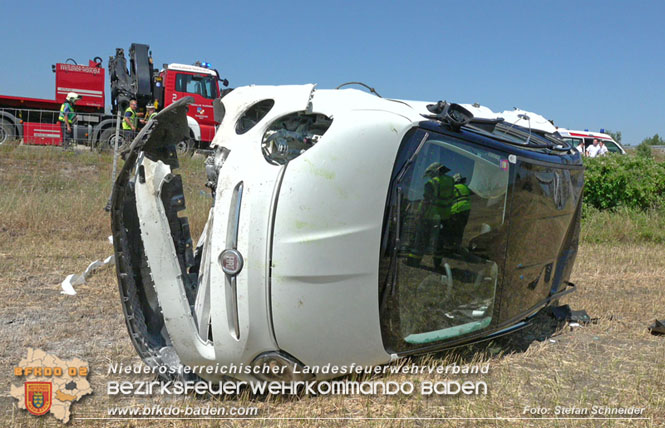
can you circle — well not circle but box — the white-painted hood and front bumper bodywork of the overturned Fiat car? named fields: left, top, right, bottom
left=135, top=84, right=576, bottom=380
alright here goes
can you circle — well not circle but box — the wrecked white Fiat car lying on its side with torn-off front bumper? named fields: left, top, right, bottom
left=112, top=85, right=583, bottom=381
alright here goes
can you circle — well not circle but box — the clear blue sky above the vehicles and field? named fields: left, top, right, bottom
left=0, top=0, right=665, bottom=144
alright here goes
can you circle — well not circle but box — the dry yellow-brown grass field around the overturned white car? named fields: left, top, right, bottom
left=0, top=145, right=665, bottom=427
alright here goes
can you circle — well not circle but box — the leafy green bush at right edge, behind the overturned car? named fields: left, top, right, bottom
left=584, top=155, right=665, bottom=210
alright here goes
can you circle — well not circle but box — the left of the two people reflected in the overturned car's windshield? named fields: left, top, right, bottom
left=406, top=162, right=455, bottom=270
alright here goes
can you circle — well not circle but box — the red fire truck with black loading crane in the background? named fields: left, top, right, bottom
left=0, top=43, right=228, bottom=151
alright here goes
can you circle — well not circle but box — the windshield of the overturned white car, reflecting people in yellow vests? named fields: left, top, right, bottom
left=380, top=136, right=509, bottom=351
